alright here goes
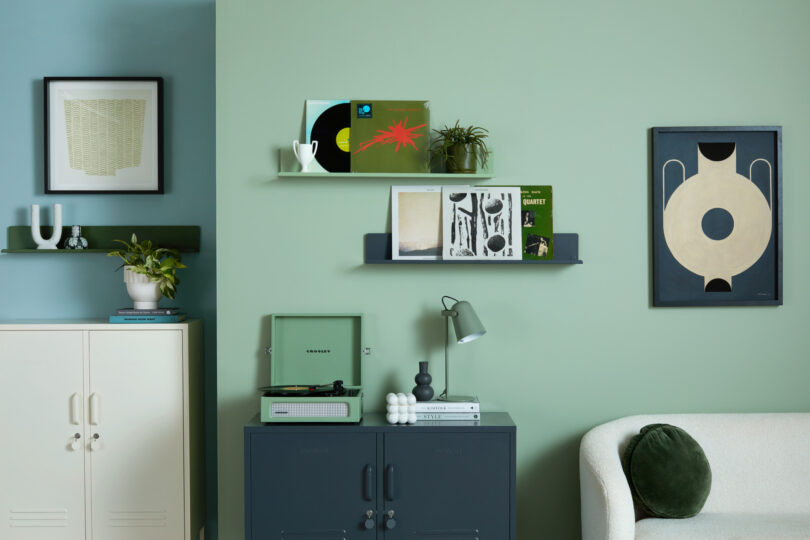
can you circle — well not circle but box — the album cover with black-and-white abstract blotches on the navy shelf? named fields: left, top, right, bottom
left=442, top=186, right=522, bottom=260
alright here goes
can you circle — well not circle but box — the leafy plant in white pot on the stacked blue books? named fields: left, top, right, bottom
left=107, top=234, right=186, bottom=309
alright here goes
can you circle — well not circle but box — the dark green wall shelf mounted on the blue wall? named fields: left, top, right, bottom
left=0, top=225, right=200, bottom=253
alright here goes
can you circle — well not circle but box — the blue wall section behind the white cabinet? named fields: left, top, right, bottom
left=0, top=0, right=216, bottom=538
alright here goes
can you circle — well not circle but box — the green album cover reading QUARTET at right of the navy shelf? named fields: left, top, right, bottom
left=520, top=186, right=554, bottom=261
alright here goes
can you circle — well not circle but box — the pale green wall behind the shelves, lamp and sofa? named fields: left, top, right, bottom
left=217, top=0, right=810, bottom=540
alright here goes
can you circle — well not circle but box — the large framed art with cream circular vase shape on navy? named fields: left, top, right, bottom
left=651, top=126, right=782, bottom=306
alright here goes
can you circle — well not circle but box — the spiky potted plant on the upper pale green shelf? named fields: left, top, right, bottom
left=430, top=120, right=489, bottom=173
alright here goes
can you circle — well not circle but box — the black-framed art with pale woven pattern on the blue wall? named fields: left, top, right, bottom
left=44, top=77, right=163, bottom=194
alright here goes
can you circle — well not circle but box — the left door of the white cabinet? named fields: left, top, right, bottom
left=0, top=331, right=85, bottom=540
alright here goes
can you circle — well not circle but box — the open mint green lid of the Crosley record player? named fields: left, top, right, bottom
left=270, top=313, right=363, bottom=386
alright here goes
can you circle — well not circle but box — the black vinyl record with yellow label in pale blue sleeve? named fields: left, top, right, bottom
left=307, top=100, right=351, bottom=172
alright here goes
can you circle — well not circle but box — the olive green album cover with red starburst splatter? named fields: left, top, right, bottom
left=350, top=100, right=430, bottom=173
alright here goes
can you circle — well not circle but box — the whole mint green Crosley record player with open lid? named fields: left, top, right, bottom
left=260, top=314, right=368, bottom=423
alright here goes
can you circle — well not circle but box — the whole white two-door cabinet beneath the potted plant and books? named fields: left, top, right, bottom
left=0, top=322, right=204, bottom=540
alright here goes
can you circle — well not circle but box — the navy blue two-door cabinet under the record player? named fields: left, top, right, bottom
left=245, top=413, right=515, bottom=540
